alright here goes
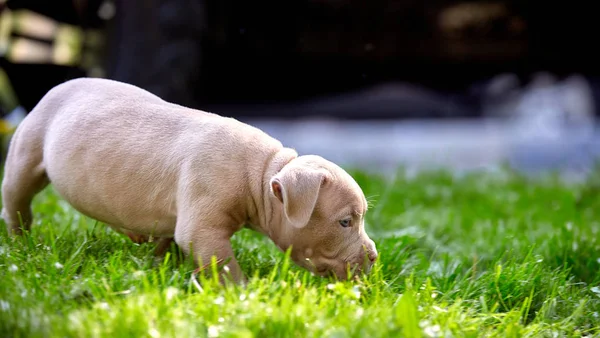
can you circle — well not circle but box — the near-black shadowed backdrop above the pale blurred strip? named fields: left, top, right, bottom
left=0, top=0, right=600, bottom=119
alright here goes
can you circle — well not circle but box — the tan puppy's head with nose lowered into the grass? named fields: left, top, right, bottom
left=270, top=155, right=377, bottom=279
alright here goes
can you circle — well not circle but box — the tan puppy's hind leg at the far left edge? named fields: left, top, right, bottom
left=2, top=121, right=49, bottom=235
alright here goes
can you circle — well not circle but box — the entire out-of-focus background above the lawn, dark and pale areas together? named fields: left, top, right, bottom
left=0, top=0, right=600, bottom=177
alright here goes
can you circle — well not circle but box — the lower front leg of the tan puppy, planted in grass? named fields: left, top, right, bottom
left=175, top=215, right=246, bottom=284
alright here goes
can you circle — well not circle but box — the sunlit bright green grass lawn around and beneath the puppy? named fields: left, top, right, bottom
left=0, top=171, right=600, bottom=337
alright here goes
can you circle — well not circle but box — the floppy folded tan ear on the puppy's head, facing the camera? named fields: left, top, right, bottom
left=271, top=168, right=326, bottom=228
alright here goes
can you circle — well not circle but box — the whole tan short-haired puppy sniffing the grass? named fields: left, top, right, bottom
left=2, top=78, right=377, bottom=282
